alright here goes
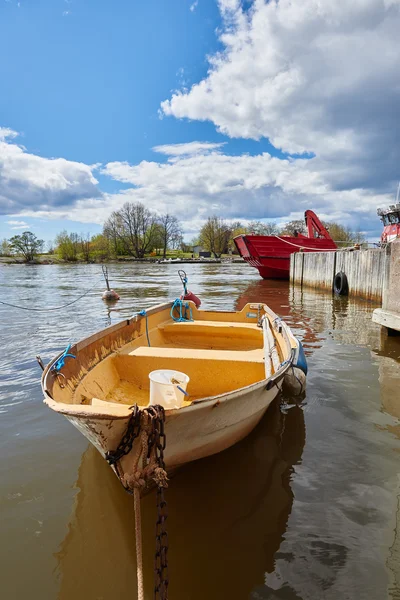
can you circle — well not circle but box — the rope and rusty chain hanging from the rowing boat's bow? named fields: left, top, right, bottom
left=106, top=404, right=169, bottom=600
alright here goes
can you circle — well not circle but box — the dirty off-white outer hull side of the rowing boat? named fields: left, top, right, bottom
left=64, top=381, right=281, bottom=475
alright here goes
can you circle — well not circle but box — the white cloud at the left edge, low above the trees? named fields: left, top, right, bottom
left=0, top=128, right=101, bottom=214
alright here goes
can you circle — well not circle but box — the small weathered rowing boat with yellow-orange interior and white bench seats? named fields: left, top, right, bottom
left=42, top=302, right=304, bottom=492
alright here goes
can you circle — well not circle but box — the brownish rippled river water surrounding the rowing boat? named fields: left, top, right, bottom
left=0, top=264, right=400, bottom=600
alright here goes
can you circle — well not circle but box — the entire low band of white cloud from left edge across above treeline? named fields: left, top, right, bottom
left=0, top=126, right=393, bottom=235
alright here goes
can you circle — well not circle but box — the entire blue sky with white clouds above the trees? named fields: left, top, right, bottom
left=0, top=0, right=400, bottom=244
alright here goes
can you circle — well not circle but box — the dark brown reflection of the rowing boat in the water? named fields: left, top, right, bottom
left=56, top=402, right=305, bottom=600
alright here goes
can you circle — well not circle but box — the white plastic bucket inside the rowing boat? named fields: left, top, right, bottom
left=149, top=369, right=189, bottom=409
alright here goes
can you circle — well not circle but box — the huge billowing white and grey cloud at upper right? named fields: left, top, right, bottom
left=162, top=0, right=400, bottom=195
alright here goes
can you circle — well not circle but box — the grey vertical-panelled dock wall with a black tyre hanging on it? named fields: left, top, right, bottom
left=290, top=246, right=390, bottom=302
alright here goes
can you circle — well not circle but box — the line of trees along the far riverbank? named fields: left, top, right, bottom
left=0, top=202, right=365, bottom=262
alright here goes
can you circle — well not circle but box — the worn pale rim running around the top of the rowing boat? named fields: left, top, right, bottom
left=41, top=302, right=298, bottom=420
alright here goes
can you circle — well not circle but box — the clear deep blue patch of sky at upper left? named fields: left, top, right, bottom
left=0, top=0, right=220, bottom=164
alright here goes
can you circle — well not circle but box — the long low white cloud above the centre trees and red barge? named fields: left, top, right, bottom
left=101, top=153, right=392, bottom=236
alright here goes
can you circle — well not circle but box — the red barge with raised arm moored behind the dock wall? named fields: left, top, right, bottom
left=234, top=210, right=337, bottom=279
